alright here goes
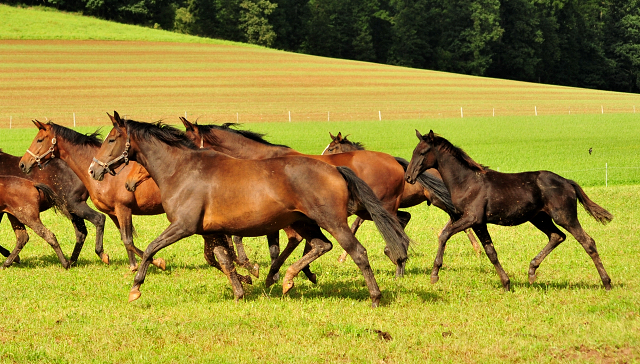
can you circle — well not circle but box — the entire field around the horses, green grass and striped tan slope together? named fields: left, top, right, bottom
left=0, top=5, right=640, bottom=363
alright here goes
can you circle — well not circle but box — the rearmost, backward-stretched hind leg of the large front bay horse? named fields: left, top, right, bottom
left=325, top=226, right=382, bottom=307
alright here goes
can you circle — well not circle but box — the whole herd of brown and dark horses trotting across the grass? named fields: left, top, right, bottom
left=0, top=112, right=613, bottom=307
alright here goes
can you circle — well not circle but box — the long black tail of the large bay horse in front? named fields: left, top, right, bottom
left=336, top=166, right=410, bottom=263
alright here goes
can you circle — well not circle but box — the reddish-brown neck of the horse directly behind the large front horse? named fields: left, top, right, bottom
left=211, top=130, right=300, bottom=159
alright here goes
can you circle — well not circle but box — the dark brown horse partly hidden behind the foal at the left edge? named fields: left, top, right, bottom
left=0, top=149, right=109, bottom=265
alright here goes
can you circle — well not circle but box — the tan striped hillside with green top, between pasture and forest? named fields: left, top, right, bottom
left=0, top=5, right=640, bottom=127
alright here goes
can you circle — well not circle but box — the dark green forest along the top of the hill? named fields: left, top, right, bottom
left=10, top=0, right=640, bottom=92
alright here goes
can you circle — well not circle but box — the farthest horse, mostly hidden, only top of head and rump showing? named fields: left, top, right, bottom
left=322, top=132, right=480, bottom=262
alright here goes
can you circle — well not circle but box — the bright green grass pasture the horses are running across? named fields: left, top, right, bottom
left=0, top=115, right=640, bottom=363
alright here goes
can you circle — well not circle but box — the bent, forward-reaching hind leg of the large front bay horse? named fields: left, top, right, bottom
left=282, top=222, right=333, bottom=294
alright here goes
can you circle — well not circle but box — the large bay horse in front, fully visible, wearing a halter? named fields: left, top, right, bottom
left=89, top=112, right=409, bottom=307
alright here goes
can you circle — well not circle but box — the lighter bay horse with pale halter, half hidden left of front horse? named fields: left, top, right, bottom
left=19, top=120, right=258, bottom=283
